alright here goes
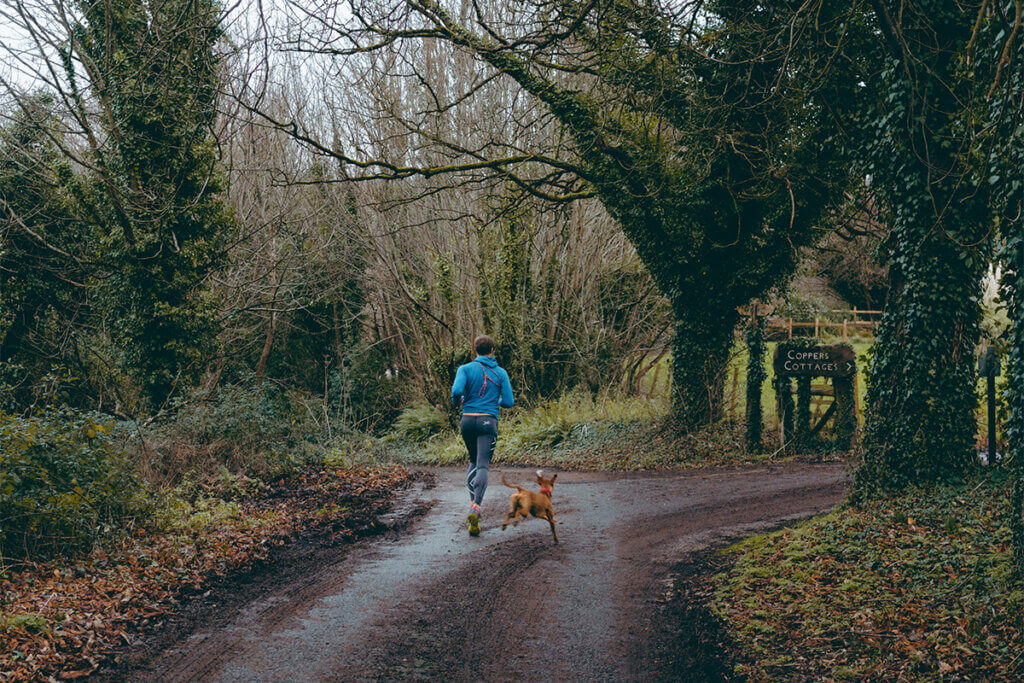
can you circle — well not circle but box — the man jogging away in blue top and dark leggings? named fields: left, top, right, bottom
left=452, top=335, right=514, bottom=536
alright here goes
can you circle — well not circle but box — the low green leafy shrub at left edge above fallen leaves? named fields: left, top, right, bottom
left=0, top=409, right=152, bottom=559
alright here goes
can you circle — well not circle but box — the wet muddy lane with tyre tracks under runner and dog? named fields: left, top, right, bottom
left=134, top=464, right=845, bottom=681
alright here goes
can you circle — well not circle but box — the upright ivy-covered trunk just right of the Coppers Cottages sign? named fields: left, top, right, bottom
left=856, top=0, right=991, bottom=489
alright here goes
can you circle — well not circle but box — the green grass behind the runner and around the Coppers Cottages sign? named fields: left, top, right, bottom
left=376, top=331, right=1001, bottom=469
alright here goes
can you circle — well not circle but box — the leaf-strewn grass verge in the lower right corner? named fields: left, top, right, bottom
left=713, top=473, right=1024, bottom=681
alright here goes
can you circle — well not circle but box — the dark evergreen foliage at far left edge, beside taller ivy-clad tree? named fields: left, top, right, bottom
left=0, top=94, right=88, bottom=411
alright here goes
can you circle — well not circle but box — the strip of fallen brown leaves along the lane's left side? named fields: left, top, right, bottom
left=0, top=467, right=412, bottom=681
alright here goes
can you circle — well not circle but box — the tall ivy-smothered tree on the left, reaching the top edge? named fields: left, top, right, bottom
left=65, top=0, right=232, bottom=410
